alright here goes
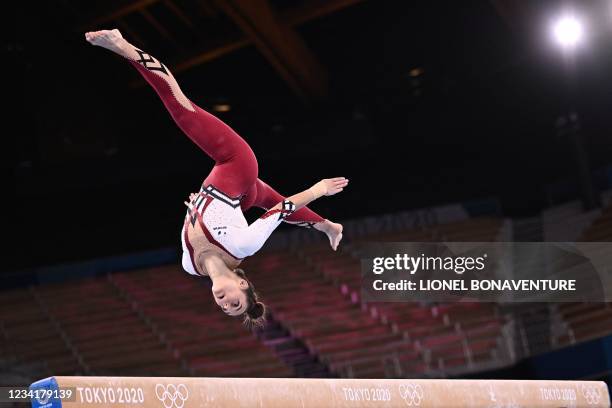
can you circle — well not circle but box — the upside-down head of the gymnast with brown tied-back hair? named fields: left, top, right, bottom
left=212, top=269, right=266, bottom=328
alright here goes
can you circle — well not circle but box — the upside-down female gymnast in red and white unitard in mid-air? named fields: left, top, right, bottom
left=85, top=29, right=348, bottom=326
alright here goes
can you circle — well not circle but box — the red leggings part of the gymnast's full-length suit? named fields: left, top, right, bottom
left=130, top=60, right=324, bottom=226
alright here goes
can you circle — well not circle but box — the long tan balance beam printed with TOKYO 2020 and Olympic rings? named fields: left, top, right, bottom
left=30, top=377, right=610, bottom=408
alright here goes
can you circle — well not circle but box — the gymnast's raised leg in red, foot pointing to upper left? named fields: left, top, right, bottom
left=85, top=30, right=258, bottom=197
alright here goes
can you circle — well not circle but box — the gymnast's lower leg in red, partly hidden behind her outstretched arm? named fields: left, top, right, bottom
left=243, top=179, right=342, bottom=251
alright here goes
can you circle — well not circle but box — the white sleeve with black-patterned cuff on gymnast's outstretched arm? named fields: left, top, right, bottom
left=228, top=200, right=295, bottom=258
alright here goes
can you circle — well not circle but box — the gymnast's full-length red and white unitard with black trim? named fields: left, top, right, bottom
left=127, top=48, right=324, bottom=275
